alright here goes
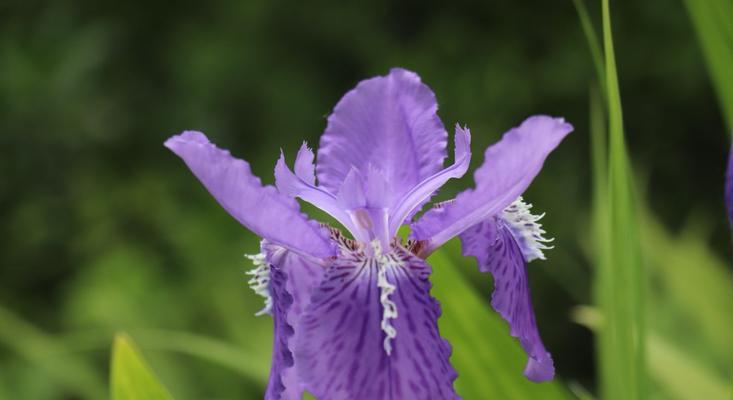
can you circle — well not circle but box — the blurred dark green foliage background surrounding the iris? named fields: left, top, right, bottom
left=0, top=0, right=733, bottom=399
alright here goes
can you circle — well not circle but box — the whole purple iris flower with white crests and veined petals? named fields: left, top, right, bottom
left=165, top=69, right=573, bottom=400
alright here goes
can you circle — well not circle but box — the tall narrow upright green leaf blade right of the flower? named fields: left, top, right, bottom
left=596, top=0, right=647, bottom=400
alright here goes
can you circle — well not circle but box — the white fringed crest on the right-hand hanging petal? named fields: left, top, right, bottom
left=500, top=196, right=555, bottom=262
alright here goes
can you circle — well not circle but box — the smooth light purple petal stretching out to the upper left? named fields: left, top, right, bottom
left=165, top=131, right=334, bottom=258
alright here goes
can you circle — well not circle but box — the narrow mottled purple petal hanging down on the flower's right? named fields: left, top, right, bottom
left=460, top=217, right=555, bottom=382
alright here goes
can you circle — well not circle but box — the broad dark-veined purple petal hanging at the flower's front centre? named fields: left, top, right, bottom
left=295, top=242, right=458, bottom=400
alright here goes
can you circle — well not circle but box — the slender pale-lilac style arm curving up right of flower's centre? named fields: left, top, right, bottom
left=389, top=124, right=471, bottom=235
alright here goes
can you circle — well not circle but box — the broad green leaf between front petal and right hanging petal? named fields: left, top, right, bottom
left=429, top=240, right=570, bottom=400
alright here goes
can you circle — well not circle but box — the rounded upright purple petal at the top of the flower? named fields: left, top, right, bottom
left=316, top=68, right=447, bottom=208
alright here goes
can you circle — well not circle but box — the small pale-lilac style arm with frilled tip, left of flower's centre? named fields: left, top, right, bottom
left=275, top=148, right=353, bottom=231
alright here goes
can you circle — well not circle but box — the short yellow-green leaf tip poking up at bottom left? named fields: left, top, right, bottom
left=110, top=334, right=172, bottom=400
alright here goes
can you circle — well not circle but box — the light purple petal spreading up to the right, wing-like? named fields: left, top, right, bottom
left=412, top=115, right=573, bottom=253
